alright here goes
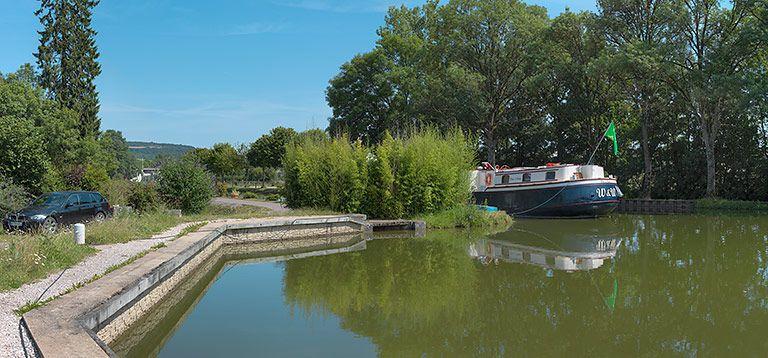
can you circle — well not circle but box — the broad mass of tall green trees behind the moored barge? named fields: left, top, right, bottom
left=326, top=0, right=768, bottom=200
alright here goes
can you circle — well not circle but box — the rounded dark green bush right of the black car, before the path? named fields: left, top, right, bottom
left=157, top=160, right=213, bottom=213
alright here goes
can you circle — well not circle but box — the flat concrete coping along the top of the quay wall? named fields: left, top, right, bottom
left=22, top=215, right=372, bottom=357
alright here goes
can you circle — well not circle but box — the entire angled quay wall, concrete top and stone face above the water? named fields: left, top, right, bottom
left=22, top=215, right=372, bottom=357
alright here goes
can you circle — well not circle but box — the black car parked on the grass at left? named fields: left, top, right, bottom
left=3, top=191, right=113, bottom=232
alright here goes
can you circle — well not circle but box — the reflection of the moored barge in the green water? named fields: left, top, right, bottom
left=469, top=220, right=621, bottom=271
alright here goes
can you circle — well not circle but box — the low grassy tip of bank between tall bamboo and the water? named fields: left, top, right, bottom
left=419, top=205, right=512, bottom=229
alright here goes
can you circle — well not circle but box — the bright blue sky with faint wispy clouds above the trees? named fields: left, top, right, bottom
left=0, top=0, right=595, bottom=146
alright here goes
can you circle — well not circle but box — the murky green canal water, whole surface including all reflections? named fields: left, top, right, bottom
left=115, top=215, right=768, bottom=357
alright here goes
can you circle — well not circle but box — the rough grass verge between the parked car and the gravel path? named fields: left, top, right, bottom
left=0, top=205, right=332, bottom=291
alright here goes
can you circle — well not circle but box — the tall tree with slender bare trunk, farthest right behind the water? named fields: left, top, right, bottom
left=670, top=0, right=764, bottom=197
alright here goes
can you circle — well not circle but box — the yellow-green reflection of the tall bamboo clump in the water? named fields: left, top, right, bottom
left=284, top=229, right=477, bottom=356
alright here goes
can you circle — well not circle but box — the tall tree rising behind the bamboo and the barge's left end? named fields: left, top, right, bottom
left=435, top=0, right=548, bottom=163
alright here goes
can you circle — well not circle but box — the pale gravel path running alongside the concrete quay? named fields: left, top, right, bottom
left=0, top=220, right=207, bottom=357
